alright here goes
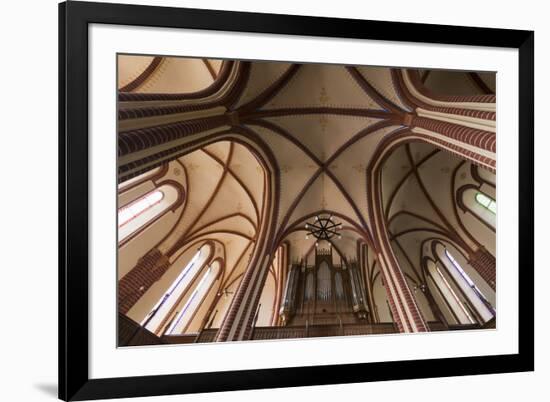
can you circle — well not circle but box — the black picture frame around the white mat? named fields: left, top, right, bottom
left=59, top=1, right=534, bottom=400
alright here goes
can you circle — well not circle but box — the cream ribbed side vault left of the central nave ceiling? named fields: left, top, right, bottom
left=158, top=141, right=265, bottom=288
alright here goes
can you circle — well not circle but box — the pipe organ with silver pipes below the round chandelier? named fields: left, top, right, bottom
left=279, top=248, right=371, bottom=325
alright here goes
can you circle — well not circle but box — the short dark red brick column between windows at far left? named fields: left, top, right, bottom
left=118, top=248, right=170, bottom=314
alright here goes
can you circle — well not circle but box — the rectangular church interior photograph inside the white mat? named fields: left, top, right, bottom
left=117, top=54, right=497, bottom=346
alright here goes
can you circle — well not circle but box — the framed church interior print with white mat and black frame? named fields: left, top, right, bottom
left=59, top=1, right=534, bottom=400
